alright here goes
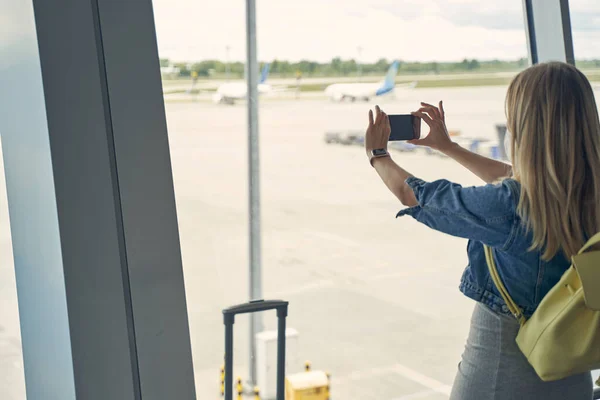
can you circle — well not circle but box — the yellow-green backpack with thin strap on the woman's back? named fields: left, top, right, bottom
left=484, top=233, right=600, bottom=381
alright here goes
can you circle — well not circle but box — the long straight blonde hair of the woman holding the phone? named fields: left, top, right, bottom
left=506, top=62, right=600, bottom=260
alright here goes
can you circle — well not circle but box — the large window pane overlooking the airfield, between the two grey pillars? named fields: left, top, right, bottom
left=154, top=0, right=528, bottom=399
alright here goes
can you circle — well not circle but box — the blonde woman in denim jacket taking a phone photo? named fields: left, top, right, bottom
left=365, top=62, right=600, bottom=400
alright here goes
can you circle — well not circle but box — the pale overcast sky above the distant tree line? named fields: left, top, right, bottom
left=153, top=0, right=600, bottom=62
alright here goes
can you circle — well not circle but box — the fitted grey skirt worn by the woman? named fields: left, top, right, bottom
left=450, top=303, right=593, bottom=400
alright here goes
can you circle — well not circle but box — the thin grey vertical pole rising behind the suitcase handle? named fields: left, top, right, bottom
left=246, top=0, right=263, bottom=387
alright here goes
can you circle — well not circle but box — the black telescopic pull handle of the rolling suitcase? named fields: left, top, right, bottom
left=223, top=300, right=288, bottom=400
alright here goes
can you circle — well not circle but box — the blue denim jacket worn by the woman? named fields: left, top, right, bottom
left=397, top=177, right=570, bottom=318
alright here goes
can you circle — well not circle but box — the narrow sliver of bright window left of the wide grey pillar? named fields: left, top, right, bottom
left=0, top=142, right=25, bottom=400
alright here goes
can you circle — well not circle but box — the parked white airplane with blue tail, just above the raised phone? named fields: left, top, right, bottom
left=325, top=61, right=417, bottom=101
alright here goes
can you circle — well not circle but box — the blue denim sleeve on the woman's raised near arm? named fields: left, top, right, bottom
left=397, top=177, right=517, bottom=248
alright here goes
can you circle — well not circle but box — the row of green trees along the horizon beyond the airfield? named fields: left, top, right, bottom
left=160, top=57, right=600, bottom=78
